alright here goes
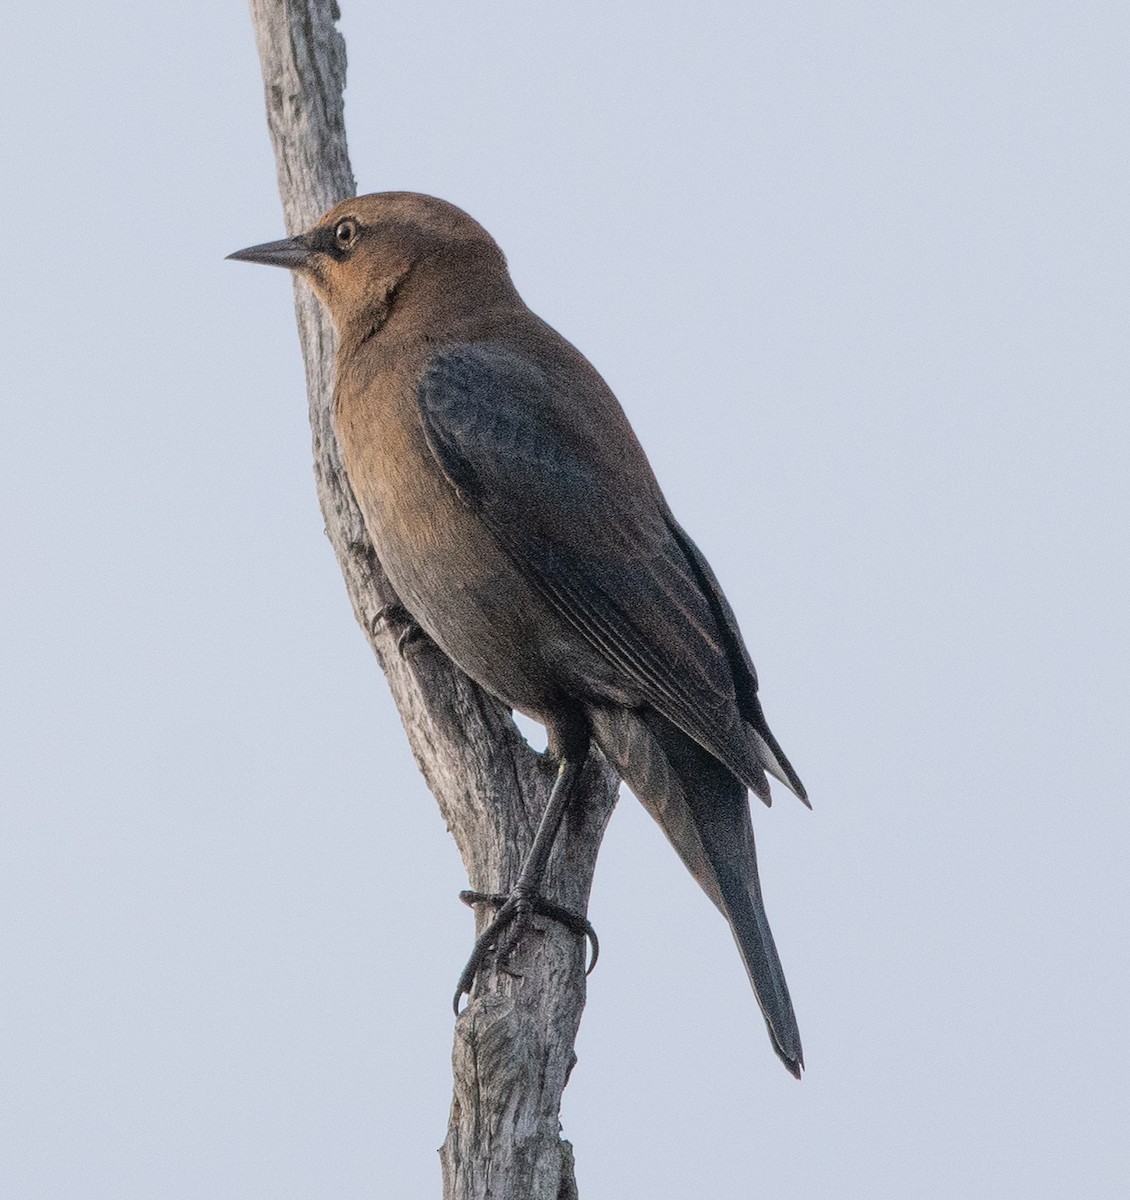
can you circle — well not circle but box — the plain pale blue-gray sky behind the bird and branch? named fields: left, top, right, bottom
left=0, top=0, right=1130, bottom=1200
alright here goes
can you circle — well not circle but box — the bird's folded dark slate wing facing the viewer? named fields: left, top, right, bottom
left=419, top=343, right=768, bottom=797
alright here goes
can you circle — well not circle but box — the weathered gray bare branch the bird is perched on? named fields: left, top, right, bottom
left=243, top=0, right=617, bottom=1200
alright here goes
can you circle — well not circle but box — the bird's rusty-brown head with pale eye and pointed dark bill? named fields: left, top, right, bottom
left=228, top=192, right=509, bottom=331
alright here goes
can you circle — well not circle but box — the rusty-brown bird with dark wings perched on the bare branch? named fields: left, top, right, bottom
left=228, top=192, right=811, bottom=1079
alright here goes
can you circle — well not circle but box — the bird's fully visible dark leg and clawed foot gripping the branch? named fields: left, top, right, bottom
left=455, top=757, right=600, bottom=1015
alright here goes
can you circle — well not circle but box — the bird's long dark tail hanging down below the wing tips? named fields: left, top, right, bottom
left=590, top=708, right=804, bottom=1079
